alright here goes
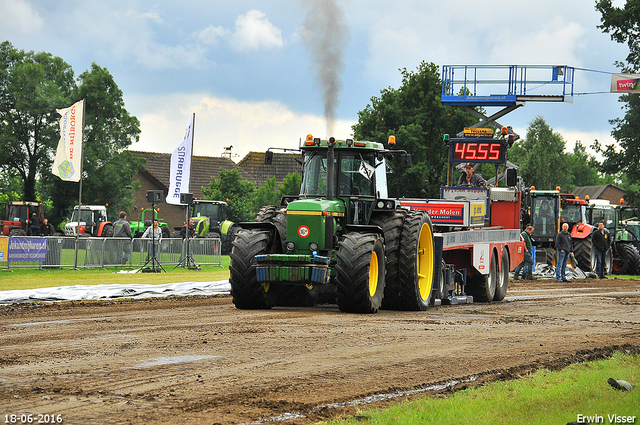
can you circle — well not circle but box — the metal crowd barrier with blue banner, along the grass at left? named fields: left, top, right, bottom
left=0, top=236, right=222, bottom=269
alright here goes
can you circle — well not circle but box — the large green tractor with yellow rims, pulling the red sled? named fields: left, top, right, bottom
left=229, top=136, right=440, bottom=313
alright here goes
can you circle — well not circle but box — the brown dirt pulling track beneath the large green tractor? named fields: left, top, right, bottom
left=0, top=279, right=640, bottom=424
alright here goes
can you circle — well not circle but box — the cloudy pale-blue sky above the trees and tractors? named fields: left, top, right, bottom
left=0, top=0, right=627, bottom=161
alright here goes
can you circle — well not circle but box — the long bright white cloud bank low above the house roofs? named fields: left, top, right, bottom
left=127, top=94, right=353, bottom=161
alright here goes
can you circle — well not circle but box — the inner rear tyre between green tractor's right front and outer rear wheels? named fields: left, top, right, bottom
left=371, top=209, right=406, bottom=310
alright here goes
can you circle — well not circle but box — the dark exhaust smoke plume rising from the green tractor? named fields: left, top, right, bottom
left=302, top=0, right=349, bottom=137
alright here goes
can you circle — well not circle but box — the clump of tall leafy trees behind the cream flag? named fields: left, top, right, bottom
left=0, top=41, right=140, bottom=224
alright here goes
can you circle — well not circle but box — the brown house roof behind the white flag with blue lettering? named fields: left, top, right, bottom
left=130, top=151, right=247, bottom=198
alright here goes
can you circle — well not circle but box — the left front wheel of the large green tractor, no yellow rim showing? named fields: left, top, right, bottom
left=229, top=230, right=273, bottom=309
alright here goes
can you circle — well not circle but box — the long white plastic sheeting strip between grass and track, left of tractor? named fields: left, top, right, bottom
left=0, top=280, right=231, bottom=305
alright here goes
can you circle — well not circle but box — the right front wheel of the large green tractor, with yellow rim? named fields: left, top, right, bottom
left=336, top=233, right=385, bottom=313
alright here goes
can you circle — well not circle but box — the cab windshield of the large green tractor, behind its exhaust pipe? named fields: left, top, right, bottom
left=300, top=151, right=376, bottom=196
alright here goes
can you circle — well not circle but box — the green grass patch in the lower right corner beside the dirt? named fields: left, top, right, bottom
left=323, top=352, right=640, bottom=425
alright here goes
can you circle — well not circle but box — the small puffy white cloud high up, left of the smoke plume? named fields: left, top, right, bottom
left=230, top=9, right=283, bottom=51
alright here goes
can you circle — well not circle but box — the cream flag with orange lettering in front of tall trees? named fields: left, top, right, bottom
left=51, top=100, right=84, bottom=182
